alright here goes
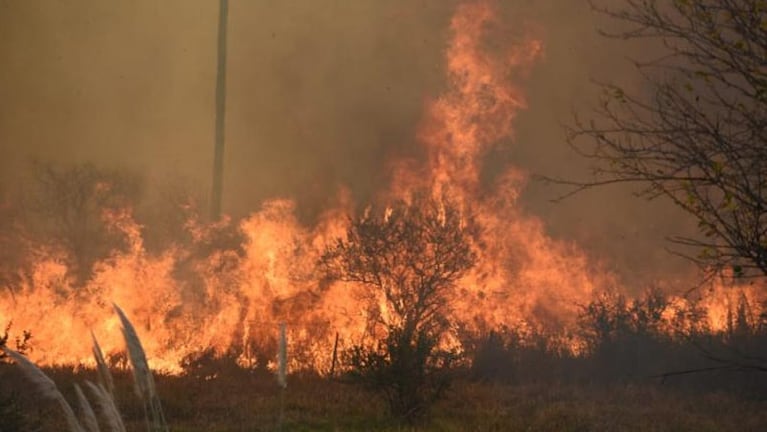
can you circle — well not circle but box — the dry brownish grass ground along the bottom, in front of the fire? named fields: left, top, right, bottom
left=0, top=369, right=767, bottom=432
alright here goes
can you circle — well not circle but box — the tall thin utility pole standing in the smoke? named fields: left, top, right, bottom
left=210, top=0, right=229, bottom=221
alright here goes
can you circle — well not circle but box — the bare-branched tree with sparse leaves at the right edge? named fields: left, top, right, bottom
left=549, top=0, right=767, bottom=276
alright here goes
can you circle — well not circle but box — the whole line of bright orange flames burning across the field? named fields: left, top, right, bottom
left=0, top=1, right=758, bottom=371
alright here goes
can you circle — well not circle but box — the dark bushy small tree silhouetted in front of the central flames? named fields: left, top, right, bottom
left=321, top=198, right=475, bottom=421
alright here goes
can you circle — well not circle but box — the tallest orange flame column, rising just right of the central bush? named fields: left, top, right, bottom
left=394, top=2, right=613, bottom=334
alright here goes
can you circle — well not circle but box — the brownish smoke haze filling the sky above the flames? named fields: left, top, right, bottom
left=0, top=0, right=690, bottom=292
